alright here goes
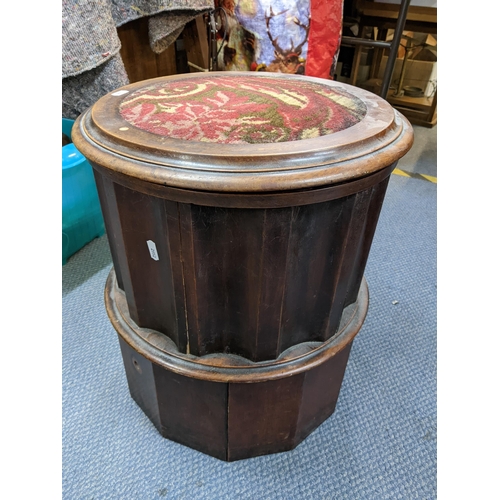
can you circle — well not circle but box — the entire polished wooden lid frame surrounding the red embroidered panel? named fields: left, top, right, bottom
left=72, top=72, right=413, bottom=192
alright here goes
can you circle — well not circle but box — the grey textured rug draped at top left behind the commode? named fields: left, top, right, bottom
left=62, top=0, right=213, bottom=119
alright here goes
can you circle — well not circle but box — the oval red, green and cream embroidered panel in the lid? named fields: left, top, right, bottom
left=120, top=76, right=366, bottom=144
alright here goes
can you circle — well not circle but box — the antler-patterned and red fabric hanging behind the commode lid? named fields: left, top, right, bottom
left=215, top=0, right=343, bottom=79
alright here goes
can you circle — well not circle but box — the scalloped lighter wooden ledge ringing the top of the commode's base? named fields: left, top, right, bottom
left=105, top=269, right=369, bottom=383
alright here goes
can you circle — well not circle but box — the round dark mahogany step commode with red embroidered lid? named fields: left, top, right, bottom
left=72, top=72, right=413, bottom=461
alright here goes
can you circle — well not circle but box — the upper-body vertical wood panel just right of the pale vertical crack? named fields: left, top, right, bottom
left=186, top=205, right=265, bottom=359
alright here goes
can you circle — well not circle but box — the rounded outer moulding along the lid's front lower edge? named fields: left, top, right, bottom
left=72, top=110, right=413, bottom=194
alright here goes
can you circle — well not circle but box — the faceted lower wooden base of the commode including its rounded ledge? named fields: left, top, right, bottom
left=105, top=270, right=368, bottom=461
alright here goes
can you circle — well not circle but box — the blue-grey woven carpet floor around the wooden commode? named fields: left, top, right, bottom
left=62, top=166, right=437, bottom=500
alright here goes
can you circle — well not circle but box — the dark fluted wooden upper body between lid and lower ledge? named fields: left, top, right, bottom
left=96, top=168, right=387, bottom=361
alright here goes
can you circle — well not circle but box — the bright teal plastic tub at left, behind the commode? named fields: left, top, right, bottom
left=62, top=118, right=105, bottom=265
